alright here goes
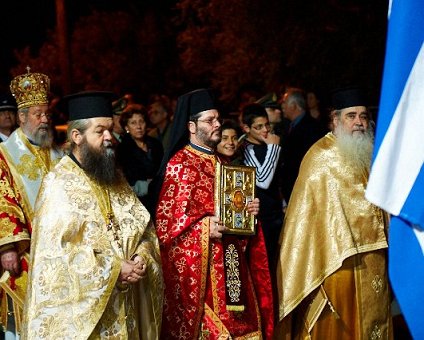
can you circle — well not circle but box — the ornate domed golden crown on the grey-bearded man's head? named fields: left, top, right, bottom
left=10, top=66, right=50, bottom=109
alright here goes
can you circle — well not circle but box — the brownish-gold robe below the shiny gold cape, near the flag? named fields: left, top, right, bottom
left=283, top=249, right=392, bottom=340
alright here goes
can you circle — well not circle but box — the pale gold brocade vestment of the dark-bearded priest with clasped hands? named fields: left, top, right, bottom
left=22, top=157, right=163, bottom=340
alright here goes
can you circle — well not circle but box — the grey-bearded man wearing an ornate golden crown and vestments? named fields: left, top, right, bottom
left=0, top=70, right=63, bottom=338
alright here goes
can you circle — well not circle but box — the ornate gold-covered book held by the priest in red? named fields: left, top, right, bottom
left=214, top=162, right=256, bottom=235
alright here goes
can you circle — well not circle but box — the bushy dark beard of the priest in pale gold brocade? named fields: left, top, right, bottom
left=80, top=141, right=122, bottom=185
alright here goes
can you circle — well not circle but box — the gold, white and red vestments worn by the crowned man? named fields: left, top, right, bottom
left=0, top=128, right=63, bottom=333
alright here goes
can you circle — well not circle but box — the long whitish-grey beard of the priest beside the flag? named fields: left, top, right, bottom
left=334, top=124, right=374, bottom=172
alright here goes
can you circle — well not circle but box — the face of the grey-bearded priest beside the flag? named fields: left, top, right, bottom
left=333, top=106, right=369, bottom=136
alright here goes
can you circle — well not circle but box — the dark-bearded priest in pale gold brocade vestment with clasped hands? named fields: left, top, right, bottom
left=22, top=92, right=163, bottom=340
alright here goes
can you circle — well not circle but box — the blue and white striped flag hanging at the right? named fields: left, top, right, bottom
left=366, top=0, right=424, bottom=339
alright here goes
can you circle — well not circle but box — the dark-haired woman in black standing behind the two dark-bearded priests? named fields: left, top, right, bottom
left=117, top=107, right=163, bottom=211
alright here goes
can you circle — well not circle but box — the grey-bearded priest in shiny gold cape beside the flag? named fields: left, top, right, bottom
left=276, top=88, right=392, bottom=339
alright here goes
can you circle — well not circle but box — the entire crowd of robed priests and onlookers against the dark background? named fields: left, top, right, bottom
left=0, top=69, right=393, bottom=340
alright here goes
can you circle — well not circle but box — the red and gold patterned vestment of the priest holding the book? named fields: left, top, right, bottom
left=156, top=146, right=274, bottom=339
